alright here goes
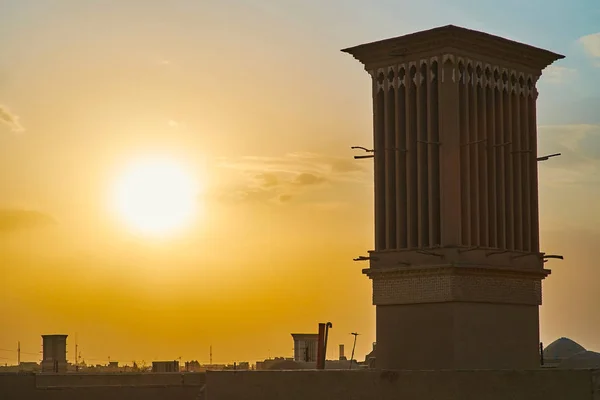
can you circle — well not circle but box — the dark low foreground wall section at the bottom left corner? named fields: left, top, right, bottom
left=0, top=373, right=206, bottom=400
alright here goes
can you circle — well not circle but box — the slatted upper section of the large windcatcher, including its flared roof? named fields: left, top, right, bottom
left=343, top=25, right=563, bottom=252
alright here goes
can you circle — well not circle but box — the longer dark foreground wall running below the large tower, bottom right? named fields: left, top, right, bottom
left=206, top=370, right=600, bottom=400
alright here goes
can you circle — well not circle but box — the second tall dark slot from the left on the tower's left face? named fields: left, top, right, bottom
left=383, top=68, right=397, bottom=249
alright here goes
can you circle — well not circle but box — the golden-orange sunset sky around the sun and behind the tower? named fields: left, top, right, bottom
left=0, top=0, right=600, bottom=363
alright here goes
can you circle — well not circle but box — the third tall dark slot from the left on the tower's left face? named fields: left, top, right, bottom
left=395, top=65, right=408, bottom=249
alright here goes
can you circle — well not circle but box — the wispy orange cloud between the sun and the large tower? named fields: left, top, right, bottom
left=220, top=153, right=367, bottom=203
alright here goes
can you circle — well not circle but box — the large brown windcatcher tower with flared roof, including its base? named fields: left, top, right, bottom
left=343, top=26, right=563, bottom=369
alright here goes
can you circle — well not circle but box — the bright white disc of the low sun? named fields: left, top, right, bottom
left=114, top=159, right=198, bottom=236
